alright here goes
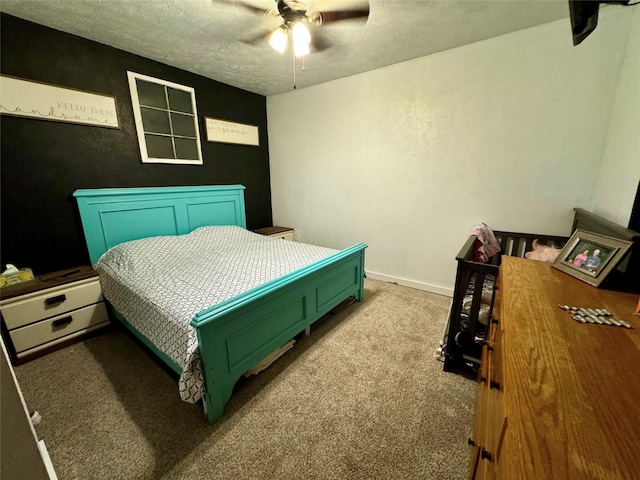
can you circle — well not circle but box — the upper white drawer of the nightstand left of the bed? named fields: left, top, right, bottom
left=0, top=277, right=103, bottom=330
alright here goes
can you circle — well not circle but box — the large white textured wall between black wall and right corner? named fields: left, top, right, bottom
left=267, top=7, right=630, bottom=292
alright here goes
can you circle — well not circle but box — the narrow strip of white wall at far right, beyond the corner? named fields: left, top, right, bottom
left=592, top=6, right=640, bottom=227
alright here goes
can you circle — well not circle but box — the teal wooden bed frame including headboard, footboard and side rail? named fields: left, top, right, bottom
left=73, top=185, right=367, bottom=423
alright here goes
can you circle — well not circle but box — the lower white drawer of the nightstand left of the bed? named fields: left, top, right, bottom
left=11, top=302, right=109, bottom=355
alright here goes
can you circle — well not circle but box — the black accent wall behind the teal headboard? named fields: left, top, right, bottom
left=0, top=14, right=271, bottom=275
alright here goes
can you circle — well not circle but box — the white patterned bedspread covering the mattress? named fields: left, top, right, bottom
left=95, top=226, right=337, bottom=403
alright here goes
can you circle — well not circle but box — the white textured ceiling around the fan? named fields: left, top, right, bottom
left=0, top=0, right=571, bottom=95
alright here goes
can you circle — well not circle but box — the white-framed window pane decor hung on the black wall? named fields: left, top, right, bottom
left=127, top=72, right=202, bottom=165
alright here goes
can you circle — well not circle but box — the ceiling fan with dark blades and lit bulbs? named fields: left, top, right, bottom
left=235, top=0, right=369, bottom=57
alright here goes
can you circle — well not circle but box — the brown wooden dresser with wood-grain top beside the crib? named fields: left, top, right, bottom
left=469, top=257, right=640, bottom=480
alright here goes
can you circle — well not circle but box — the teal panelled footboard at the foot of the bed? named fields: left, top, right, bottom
left=191, top=243, right=366, bottom=422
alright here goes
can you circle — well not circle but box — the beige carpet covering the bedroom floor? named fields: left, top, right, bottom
left=16, top=279, right=475, bottom=480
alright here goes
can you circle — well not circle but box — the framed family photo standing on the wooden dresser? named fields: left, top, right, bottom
left=553, top=230, right=631, bottom=287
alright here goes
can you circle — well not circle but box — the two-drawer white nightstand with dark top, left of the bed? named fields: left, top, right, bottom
left=0, top=266, right=109, bottom=360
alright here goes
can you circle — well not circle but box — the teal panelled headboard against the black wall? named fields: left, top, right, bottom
left=73, top=185, right=247, bottom=265
